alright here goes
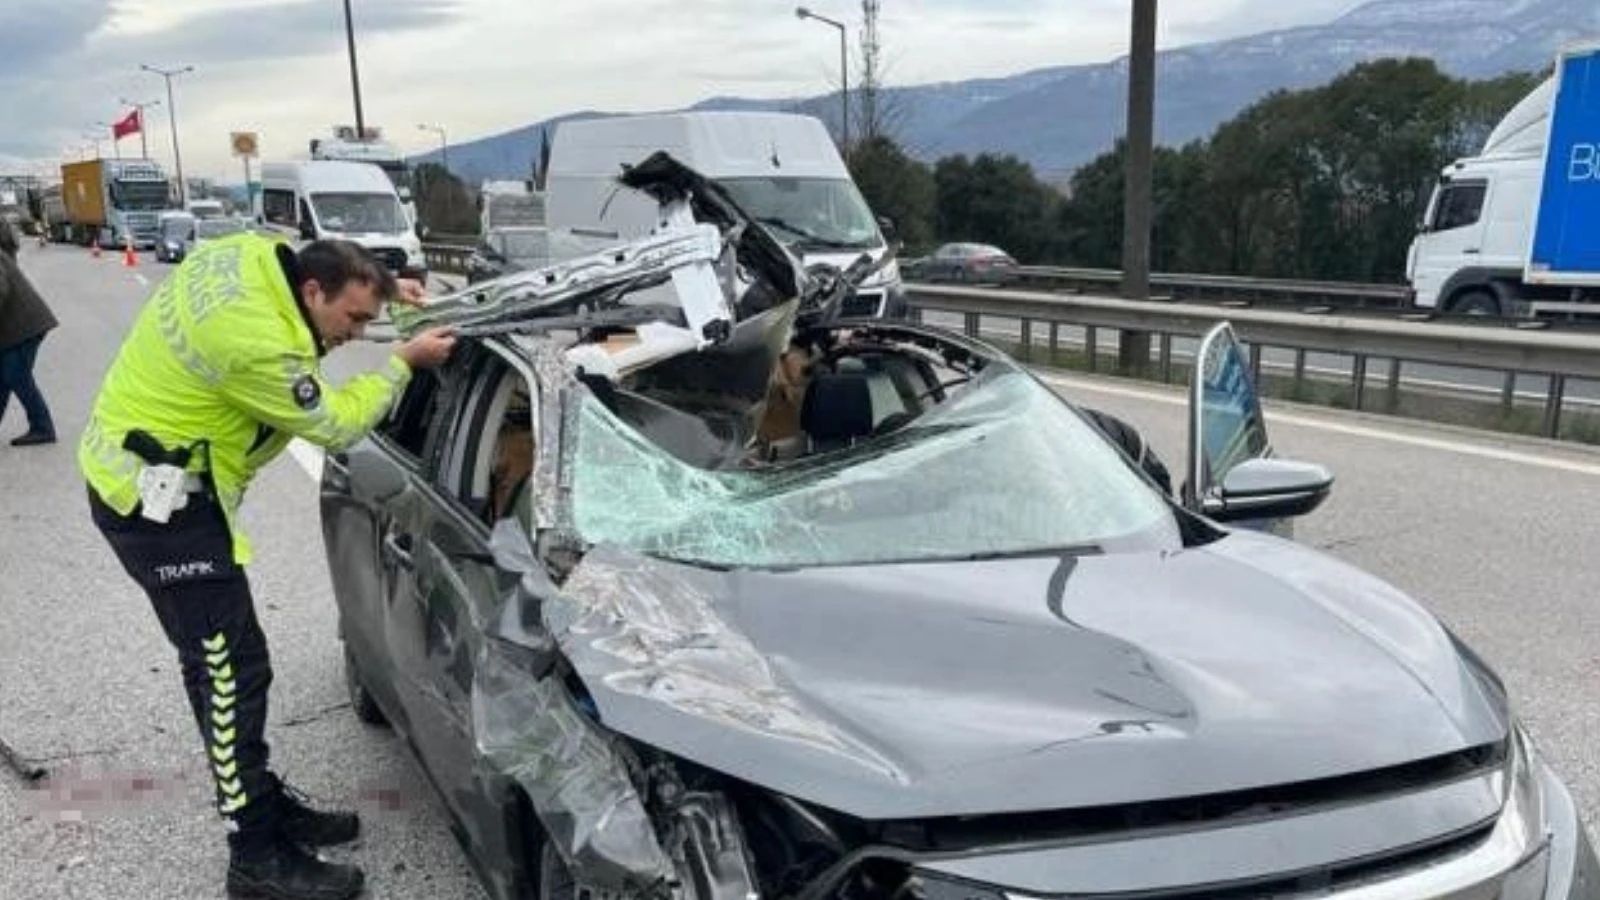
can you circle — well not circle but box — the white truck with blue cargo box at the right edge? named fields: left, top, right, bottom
left=1406, top=46, right=1600, bottom=315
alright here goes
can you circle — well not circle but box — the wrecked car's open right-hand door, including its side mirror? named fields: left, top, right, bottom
left=1182, top=322, right=1333, bottom=538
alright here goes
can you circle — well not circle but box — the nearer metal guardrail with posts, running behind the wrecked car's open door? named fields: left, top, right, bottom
left=907, top=285, right=1600, bottom=437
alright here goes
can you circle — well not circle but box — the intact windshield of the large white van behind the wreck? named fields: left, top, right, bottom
left=718, top=178, right=883, bottom=250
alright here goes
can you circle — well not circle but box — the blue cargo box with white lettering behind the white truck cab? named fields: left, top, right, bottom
left=1528, top=48, right=1600, bottom=275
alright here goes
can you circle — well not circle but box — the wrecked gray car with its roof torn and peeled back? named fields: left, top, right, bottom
left=322, top=159, right=1600, bottom=900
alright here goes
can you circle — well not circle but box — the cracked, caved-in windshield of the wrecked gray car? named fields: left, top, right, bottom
left=571, top=361, right=1179, bottom=569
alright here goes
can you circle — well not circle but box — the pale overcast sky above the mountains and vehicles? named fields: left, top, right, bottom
left=0, top=0, right=1360, bottom=181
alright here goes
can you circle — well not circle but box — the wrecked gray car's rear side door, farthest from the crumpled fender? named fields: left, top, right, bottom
left=322, top=372, right=442, bottom=729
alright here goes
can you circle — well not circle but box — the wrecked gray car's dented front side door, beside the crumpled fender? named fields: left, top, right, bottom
left=379, top=348, right=536, bottom=822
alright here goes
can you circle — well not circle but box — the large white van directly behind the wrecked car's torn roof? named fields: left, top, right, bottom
left=546, top=112, right=904, bottom=315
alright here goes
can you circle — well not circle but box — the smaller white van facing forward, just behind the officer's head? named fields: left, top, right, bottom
left=256, top=160, right=427, bottom=282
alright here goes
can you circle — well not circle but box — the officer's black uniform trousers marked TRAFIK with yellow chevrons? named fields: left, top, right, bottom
left=90, top=488, right=282, bottom=849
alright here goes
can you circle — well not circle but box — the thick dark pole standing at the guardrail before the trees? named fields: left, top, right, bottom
left=1117, top=0, right=1155, bottom=375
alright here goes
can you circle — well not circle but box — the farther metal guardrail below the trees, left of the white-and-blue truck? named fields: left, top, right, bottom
left=1018, top=266, right=1411, bottom=309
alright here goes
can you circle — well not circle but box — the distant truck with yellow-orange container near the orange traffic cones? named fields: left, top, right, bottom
left=51, top=159, right=176, bottom=250
